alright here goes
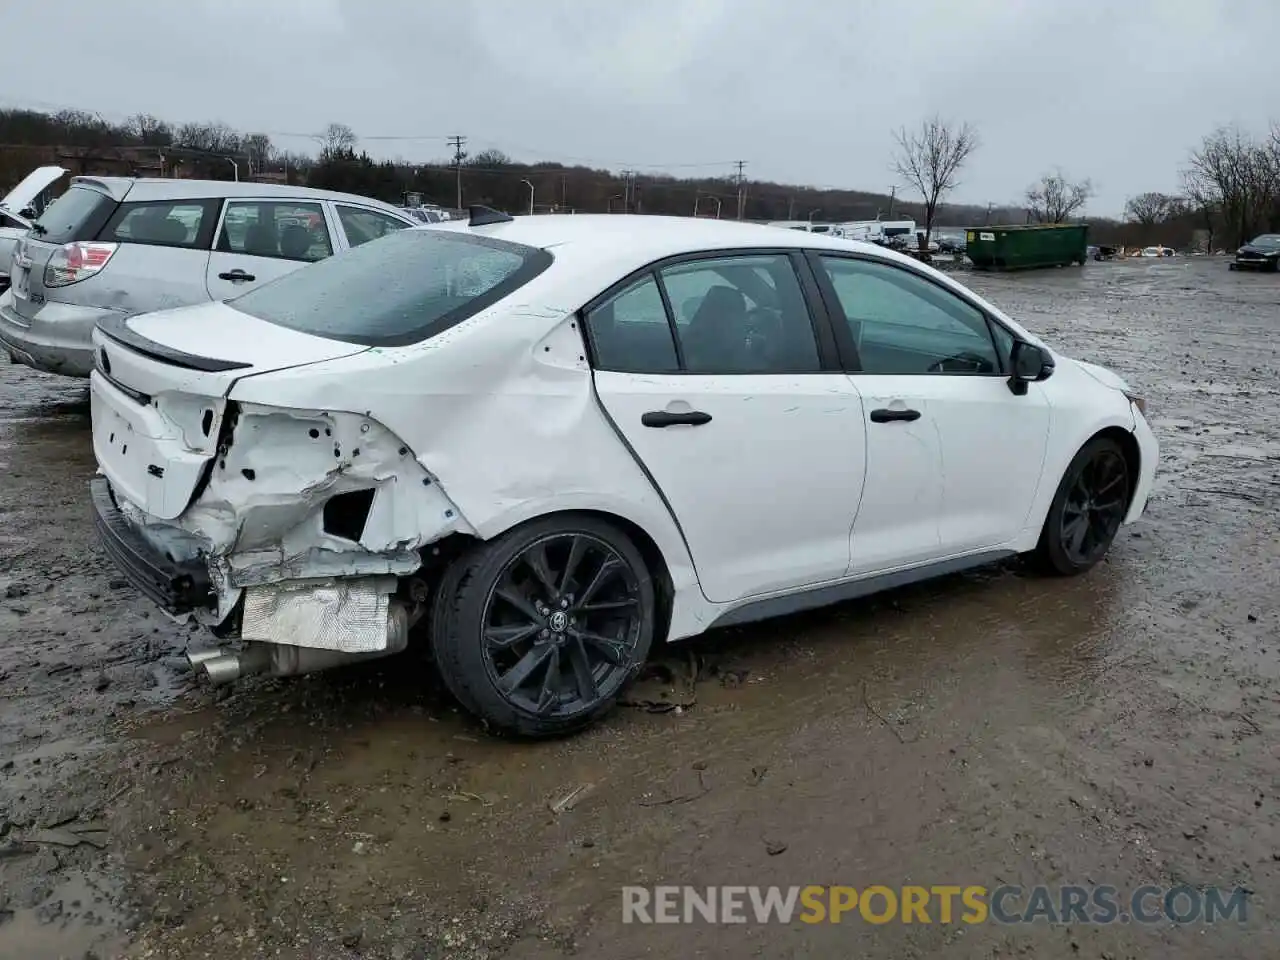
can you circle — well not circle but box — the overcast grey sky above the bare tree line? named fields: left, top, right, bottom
left=0, top=0, right=1280, bottom=214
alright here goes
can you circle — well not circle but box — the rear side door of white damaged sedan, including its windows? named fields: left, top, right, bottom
left=586, top=252, right=865, bottom=602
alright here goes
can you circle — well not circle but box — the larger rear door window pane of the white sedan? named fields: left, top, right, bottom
left=659, top=253, right=820, bottom=374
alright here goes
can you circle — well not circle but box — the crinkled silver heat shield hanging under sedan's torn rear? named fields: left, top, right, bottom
left=241, top=577, right=396, bottom=653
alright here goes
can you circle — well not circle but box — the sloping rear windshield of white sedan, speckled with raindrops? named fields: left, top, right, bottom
left=229, top=228, right=552, bottom=347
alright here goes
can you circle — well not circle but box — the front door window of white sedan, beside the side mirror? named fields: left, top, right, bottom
left=818, top=256, right=1011, bottom=375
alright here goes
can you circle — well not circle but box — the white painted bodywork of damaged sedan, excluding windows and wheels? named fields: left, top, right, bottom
left=85, top=216, right=1157, bottom=711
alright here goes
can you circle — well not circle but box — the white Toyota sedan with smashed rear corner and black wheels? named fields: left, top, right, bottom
left=85, top=207, right=1157, bottom=735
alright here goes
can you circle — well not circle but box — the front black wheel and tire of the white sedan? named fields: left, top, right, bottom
left=1030, top=436, right=1133, bottom=576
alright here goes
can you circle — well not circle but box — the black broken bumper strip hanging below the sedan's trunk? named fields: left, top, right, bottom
left=90, top=477, right=216, bottom=616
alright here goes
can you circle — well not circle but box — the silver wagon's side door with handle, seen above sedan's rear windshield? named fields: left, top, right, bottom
left=205, top=198, right=334, bottom=300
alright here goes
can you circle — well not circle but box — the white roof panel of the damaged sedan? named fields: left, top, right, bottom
left=429, top=214, right=908, bottom=266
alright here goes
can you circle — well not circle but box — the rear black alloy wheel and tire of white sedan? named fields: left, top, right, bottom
left=430, top=515, right=657, bottom=737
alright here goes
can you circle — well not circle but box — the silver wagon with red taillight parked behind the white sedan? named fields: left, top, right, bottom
left=0, top=177, right=416, bottom=376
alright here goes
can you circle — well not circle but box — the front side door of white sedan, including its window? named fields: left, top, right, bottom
left=810, top=253, right=1051, bottom=573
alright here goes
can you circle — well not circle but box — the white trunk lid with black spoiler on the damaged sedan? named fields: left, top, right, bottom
left=90, top=303, right=369, bottom=520
